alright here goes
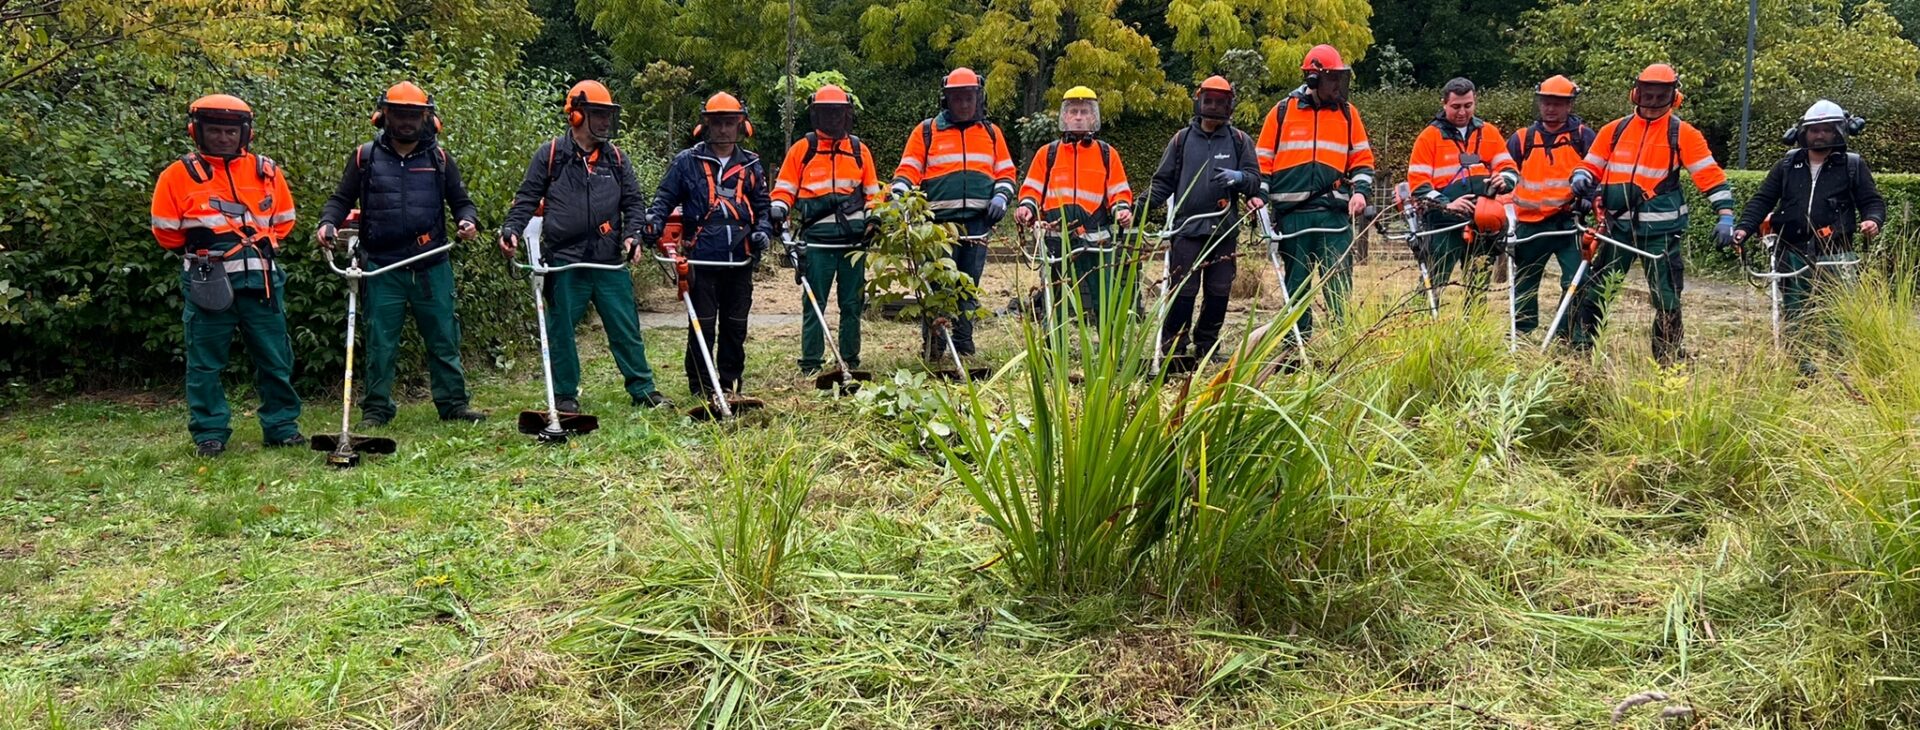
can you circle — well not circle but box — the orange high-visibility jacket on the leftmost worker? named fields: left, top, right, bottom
left=152, top=152, right=294, bottom=290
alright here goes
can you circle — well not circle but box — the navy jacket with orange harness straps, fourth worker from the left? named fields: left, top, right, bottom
left=647, top=142, right=774, bottom=261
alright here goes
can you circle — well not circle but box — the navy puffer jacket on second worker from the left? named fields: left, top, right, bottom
left=321, top=133, right=480, bottom=269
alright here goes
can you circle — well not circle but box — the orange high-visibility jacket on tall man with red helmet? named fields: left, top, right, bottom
left=1254, top=88, right=1373, bottom=213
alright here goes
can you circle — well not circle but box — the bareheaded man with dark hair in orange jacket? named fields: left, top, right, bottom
left=1407, top=79, right=1521, bottom=300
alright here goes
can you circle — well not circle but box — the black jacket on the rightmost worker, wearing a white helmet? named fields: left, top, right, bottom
left=1738, top=150, right=1887, bottom=256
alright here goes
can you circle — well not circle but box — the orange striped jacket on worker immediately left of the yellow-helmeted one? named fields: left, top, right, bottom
left=893, top=111, right=1018, bottom=223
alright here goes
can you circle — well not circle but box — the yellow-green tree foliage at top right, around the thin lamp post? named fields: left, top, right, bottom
left=1515, top=0, right=1920, bottom=142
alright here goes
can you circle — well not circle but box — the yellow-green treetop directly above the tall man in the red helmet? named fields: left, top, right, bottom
left=1167, top=0, right=1373, bottom=90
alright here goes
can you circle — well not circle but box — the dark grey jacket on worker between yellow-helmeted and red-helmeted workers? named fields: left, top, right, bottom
left=1139, top=119, right=1265, bottom=240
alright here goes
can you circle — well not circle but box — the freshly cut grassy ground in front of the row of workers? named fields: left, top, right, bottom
left=0, top=265, right=1920, bottom=728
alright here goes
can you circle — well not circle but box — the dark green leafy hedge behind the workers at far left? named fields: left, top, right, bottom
left=0, top=46, right=662, bottom=386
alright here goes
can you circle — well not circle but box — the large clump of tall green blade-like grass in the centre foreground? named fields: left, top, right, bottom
left=943, top=239, right=1356, bottom=605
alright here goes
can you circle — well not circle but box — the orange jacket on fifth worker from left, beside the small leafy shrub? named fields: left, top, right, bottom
left=774, top=133, right=879, bottom=244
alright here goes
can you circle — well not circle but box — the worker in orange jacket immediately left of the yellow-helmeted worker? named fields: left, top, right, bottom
left=891, top=67, right=1016, bottom=359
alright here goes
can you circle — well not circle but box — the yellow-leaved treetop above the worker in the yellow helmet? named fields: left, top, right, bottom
left=952, top=0, right=1187, bottom=119
